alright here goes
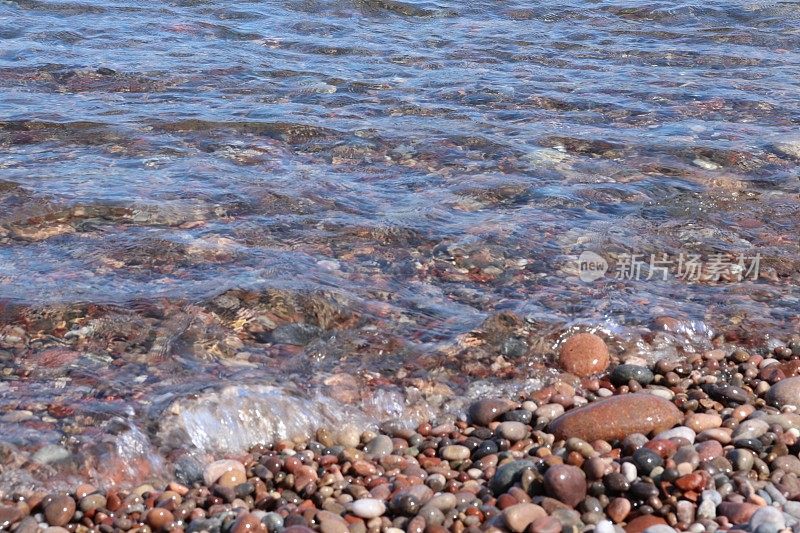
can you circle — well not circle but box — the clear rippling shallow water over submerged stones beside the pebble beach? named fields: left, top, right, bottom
left=0, top=0, right=800, bottom=486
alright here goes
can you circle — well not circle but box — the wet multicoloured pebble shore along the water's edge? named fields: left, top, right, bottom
left=0, top=333, right=800, bottom=533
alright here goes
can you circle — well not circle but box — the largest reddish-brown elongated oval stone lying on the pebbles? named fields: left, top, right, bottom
left=548, top=393, right=683, bottom=442
